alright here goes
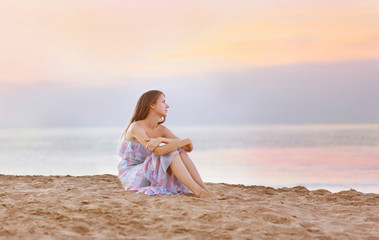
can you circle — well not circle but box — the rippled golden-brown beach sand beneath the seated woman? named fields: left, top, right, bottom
left=0, top=175, right=379, bottom=240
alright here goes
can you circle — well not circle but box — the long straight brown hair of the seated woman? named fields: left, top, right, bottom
left=121, top=90, right=166, bottom=140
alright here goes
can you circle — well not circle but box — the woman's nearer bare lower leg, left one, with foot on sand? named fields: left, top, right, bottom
left=170, top=154, right=216, bottom=199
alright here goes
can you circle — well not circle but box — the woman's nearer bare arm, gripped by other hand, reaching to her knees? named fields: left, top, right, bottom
left=130, top=123, right=192, bottom=156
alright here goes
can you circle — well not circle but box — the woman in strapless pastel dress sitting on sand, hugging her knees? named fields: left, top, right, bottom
left=118, top=90, right=221, bottom=199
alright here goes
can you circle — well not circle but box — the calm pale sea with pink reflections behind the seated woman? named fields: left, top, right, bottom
left=0, top=124, right=379, bottom=193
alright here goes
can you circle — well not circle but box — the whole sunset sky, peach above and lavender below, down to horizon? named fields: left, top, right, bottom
left=0, top=0, right=379, bottom=128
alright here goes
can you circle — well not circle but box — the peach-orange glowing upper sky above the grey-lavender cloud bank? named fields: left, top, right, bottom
left=0, top=0, right=379, bottom=82
